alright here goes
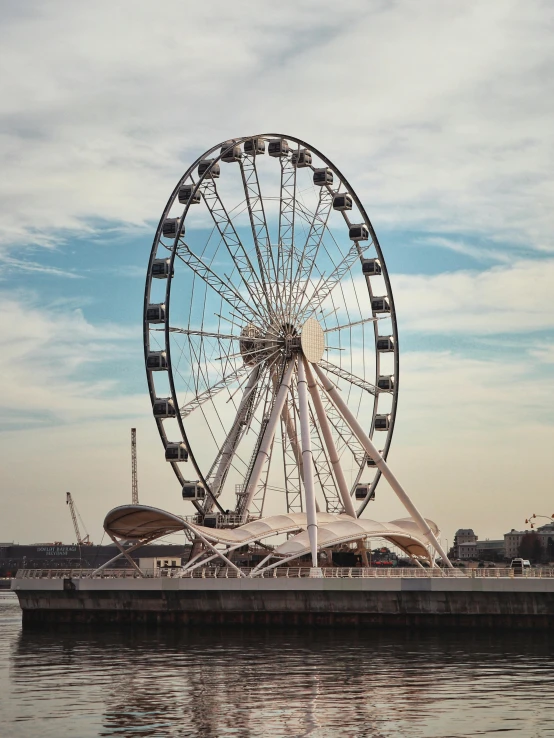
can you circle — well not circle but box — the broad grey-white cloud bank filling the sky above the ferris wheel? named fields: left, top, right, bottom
left=0, top=0, right=554, bottom=258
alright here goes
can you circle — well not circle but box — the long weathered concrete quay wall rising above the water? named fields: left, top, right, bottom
left=12, top=577, right=554, bottom=629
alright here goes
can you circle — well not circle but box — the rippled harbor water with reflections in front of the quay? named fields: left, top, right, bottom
left=0, top=592, right=554, bottom=738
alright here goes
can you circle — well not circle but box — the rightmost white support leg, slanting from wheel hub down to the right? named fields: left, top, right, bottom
left=314, top=364, right=453, bottom=568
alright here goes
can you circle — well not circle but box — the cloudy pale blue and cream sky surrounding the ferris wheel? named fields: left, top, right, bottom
left=0, top=0, right=554, bottom=544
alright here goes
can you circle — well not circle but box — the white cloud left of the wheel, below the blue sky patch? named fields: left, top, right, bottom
left=0, top=293, right=140, bottom=429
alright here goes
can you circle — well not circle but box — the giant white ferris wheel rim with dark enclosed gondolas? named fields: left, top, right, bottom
left=144, top=134, right=399, bottom=525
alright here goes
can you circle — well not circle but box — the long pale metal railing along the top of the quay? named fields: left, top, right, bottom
left=16, top=566, right=554, bottom=579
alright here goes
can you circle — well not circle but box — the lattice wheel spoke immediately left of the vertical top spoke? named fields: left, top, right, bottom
left=239, top=153, right=276, bottom=308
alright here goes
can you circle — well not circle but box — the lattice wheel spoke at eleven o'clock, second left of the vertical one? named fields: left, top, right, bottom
left=200, top=178, right=270, bottom=314
